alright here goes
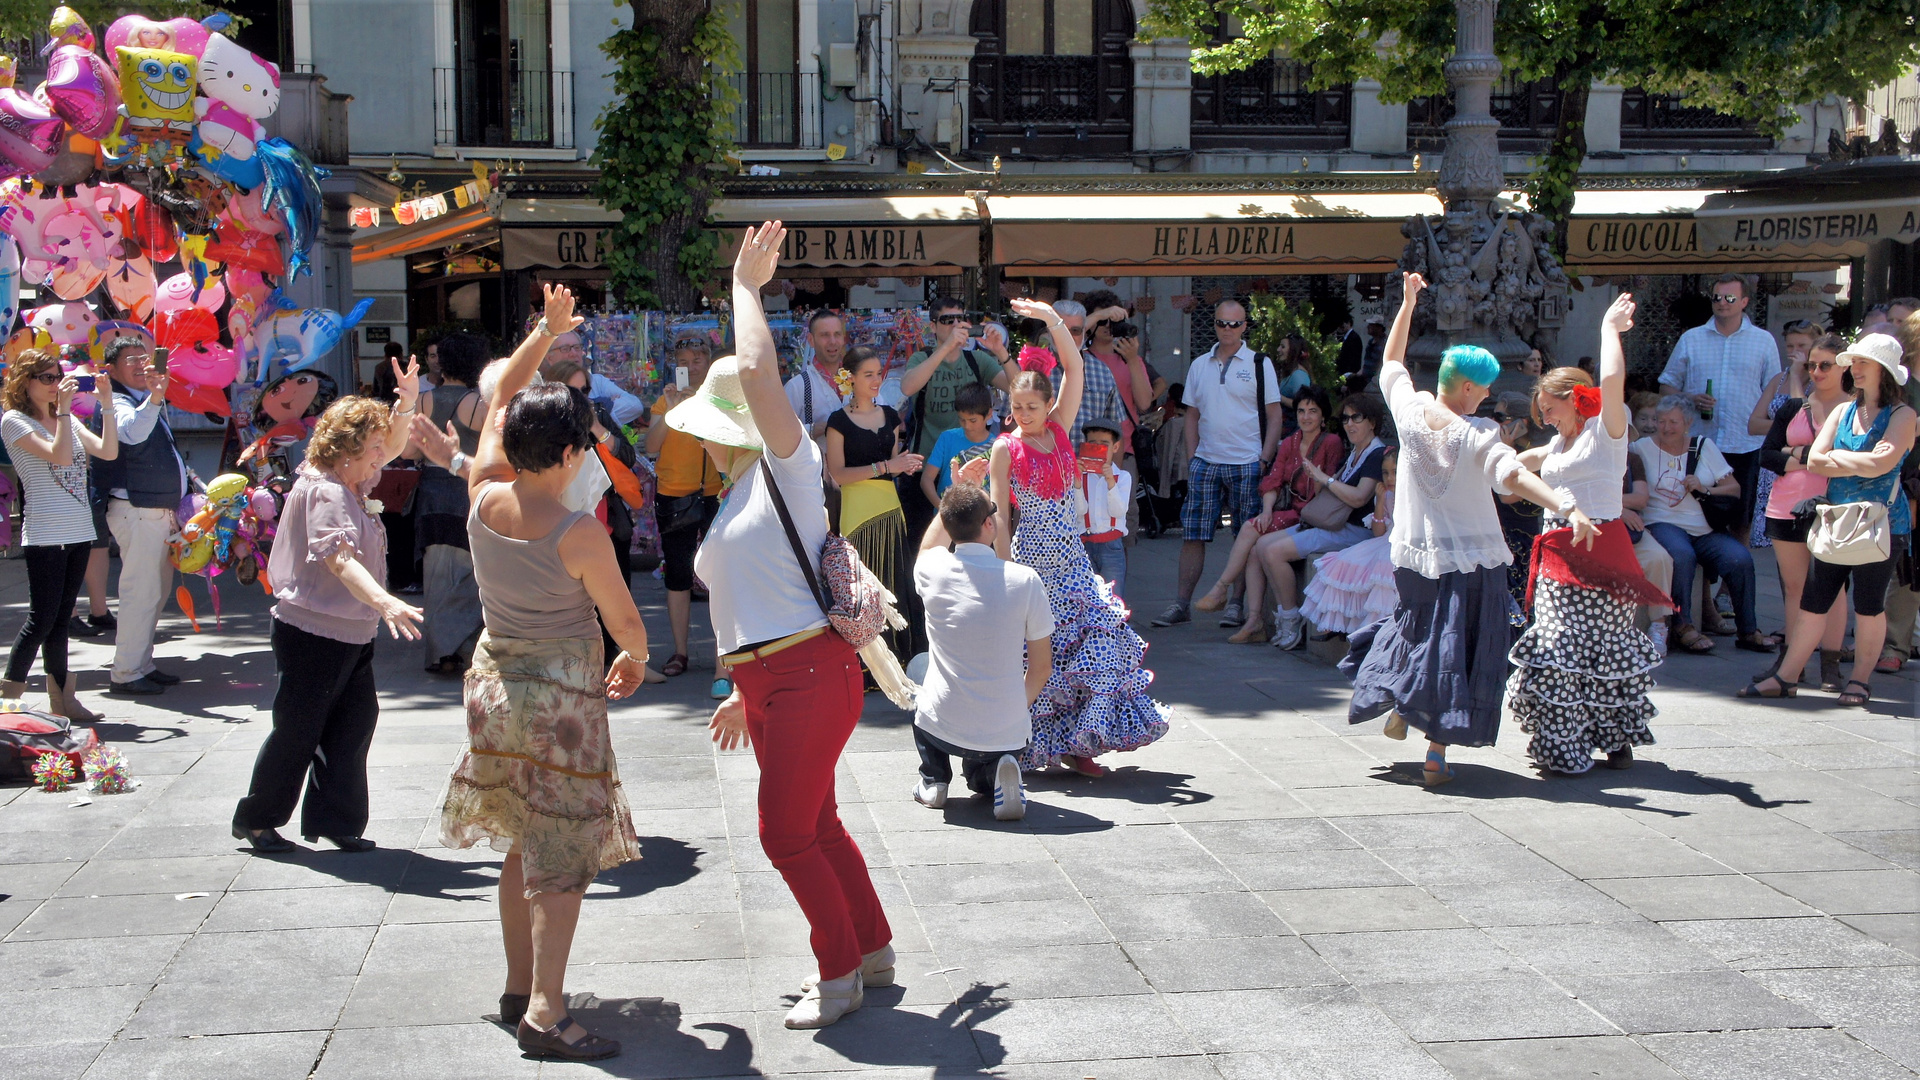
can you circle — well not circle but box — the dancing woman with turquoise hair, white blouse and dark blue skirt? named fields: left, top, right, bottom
left=1340, top=273, right=1596, bottom=786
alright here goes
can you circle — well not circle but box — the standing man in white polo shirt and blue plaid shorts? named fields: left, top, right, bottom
left=1154, top=300, right=1283, bottom=626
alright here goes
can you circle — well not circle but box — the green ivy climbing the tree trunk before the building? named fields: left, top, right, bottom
left=593, top=0, right=739, bottom=307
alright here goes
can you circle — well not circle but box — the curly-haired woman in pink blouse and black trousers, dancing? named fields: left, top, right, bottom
left=234, top=368, right=420, bottom=853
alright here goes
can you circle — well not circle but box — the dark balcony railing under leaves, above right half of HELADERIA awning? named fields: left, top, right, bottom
left=1192, top=58, right=1352, bottom=150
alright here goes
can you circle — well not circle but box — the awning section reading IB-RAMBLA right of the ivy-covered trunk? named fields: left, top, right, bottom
left=712, top=194, right=979, bottom=277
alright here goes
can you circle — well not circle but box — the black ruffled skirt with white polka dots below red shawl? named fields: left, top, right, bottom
left=1507, top=575, right=1661, bottom=773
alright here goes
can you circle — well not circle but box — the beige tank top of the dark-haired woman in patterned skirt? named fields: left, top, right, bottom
left=467, top=484, right=601, bottom=640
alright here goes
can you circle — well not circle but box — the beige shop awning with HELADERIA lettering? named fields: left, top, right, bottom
left=987, top=192, right=1442, bottom=277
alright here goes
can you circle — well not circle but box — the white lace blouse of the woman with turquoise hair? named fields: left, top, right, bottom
left=1380, top=363, right=1521, bottom=578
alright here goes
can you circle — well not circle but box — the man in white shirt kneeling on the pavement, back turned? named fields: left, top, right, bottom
left=914, top=482, right=1054, bottom=821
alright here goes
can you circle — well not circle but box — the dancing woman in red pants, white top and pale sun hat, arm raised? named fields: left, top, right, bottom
left=666, top=221, right=893, bottom=1028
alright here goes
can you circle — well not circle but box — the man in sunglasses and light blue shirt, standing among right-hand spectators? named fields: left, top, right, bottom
left=1661, top=273, right=1780, bottom=540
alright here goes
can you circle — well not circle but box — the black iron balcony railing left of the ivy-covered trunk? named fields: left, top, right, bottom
left=434, top=65, right=574, bottom=150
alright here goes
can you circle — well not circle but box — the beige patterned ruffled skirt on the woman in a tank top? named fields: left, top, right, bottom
left=440, top=634, right=639, bottom=896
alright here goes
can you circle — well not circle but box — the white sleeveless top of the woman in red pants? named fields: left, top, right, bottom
left=693, top=438, right=828, bottom=653
